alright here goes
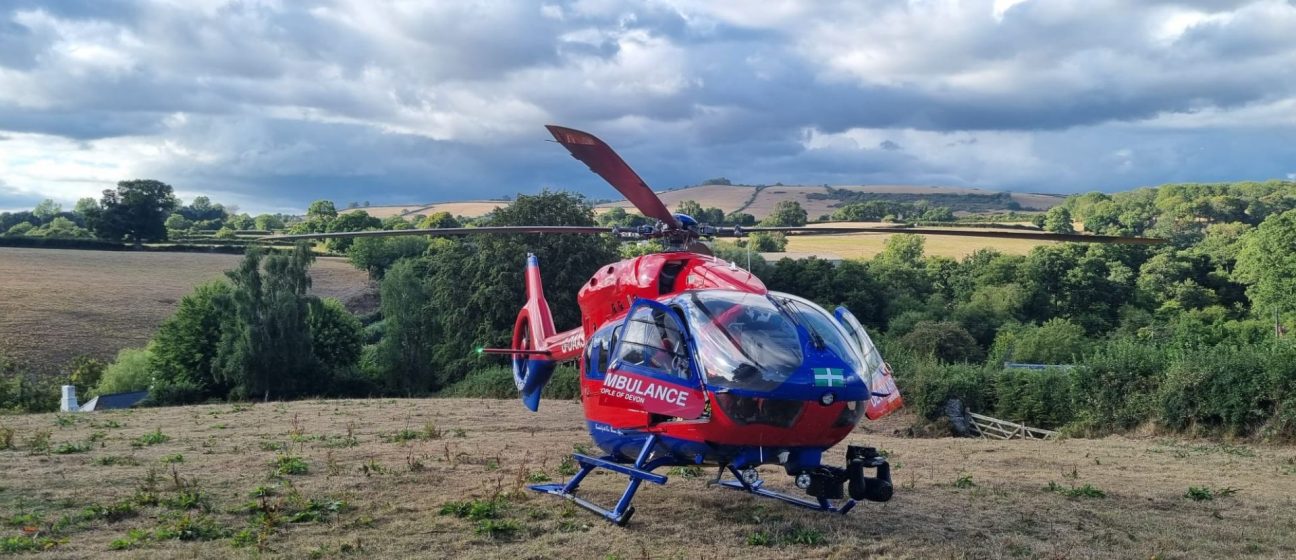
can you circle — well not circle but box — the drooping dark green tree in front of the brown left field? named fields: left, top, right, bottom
left=214, top=242, right=320, bottom=399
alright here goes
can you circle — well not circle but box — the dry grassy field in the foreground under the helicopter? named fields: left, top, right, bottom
left=0, top=399, right=1296, bottom=559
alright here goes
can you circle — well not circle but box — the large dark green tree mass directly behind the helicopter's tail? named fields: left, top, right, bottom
left=376, top=191, right=617, bottom=393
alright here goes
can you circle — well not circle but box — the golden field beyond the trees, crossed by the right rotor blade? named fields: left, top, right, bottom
left=787, top=222, right=1056, bottom=258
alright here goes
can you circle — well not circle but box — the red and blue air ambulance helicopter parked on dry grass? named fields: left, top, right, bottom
left=275, top=126, right=1163, bottom=526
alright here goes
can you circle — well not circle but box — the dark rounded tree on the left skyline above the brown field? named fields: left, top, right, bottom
left=86, top=180, right=176, bottom=245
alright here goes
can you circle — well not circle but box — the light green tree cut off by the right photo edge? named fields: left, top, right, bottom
left=1235, top=210, right=1296, bottom=314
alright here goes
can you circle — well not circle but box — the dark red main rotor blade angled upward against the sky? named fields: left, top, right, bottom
left=544, top=124, right=679, bottom=227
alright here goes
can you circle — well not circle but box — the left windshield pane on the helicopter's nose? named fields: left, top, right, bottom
left=684, top=290, right=804, bottom=390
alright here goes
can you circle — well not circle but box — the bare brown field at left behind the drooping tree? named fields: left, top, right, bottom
left=0, top=248, right=373, bottom=372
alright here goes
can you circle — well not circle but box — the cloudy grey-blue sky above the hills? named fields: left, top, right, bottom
left=0, top=0, right=1296, bottom=211
